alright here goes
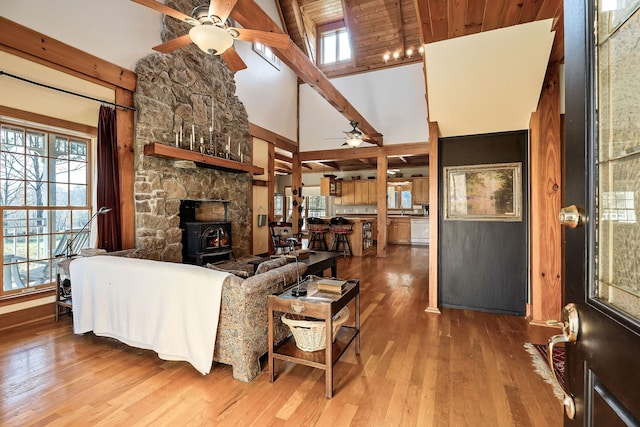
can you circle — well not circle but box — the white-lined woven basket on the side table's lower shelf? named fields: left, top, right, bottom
left=282, top=307, right=349, bottom=351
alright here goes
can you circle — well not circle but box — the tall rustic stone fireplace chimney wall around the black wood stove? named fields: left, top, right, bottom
left=134, top=1, right=252, bottom=262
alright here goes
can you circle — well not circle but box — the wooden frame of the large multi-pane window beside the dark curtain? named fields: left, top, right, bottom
left=0, top=115, right=97, bottom=300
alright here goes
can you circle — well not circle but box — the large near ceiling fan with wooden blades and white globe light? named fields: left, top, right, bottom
left=131, top=0, right=289, bottom=73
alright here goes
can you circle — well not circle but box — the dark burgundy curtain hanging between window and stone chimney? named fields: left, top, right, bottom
left=97, top=105, right=122, bottom=252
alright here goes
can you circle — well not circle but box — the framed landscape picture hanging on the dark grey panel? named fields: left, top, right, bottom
left=443, top=162, right=522, bottom=221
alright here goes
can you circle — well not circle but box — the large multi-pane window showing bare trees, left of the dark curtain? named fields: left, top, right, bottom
left=0, top=121, right=91, bottom=296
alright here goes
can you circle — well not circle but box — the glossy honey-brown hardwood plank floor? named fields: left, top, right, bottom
left=0, top=246, right=562, bottom=427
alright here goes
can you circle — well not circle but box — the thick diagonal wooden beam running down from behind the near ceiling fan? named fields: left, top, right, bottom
left=231, top=0, right=382, bottom=145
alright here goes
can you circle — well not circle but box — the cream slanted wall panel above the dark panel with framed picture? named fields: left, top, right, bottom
left=425, top=19, right=554, bottom=137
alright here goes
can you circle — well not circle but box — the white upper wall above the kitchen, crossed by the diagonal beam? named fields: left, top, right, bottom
left=300, top=63, right=429, bottom=151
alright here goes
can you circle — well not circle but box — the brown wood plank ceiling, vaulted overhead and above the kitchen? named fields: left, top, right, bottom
left=276, top=0, right=564, bottom=173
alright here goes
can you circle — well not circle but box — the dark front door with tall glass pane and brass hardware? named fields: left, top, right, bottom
left=561, top=0, right=640, bottom=426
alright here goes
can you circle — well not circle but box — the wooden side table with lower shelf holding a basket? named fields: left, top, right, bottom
left=268, top=278, right=360, bottom=399
